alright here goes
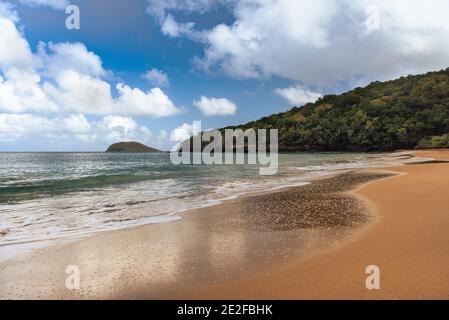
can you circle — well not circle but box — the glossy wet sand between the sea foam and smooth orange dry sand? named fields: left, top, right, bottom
left=0, top=172, right=388, bottom=299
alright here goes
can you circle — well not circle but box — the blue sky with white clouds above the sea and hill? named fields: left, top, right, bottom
left=0, top=0, right=449, bottom=152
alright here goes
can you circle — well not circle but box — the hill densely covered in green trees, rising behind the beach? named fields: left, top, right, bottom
left=229, top=68, right=449, bottom=151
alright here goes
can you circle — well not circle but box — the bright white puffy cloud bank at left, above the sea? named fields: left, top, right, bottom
left=0, top=12, right=180, bottom=118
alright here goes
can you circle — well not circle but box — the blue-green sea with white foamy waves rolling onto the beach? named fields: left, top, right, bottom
left=0, top=153, right=408, bottom=246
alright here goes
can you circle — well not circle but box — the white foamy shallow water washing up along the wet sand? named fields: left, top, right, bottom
left=0, top=153, right=416, bottom=251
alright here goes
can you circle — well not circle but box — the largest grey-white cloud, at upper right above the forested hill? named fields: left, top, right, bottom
left=148, top=0, right=449, bottom=86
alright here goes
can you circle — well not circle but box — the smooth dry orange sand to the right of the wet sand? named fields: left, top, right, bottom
left=178, top=150, right=449, bottom=300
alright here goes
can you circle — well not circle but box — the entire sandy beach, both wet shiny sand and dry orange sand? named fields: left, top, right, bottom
left=0, top=151, right=449, bottom=299
